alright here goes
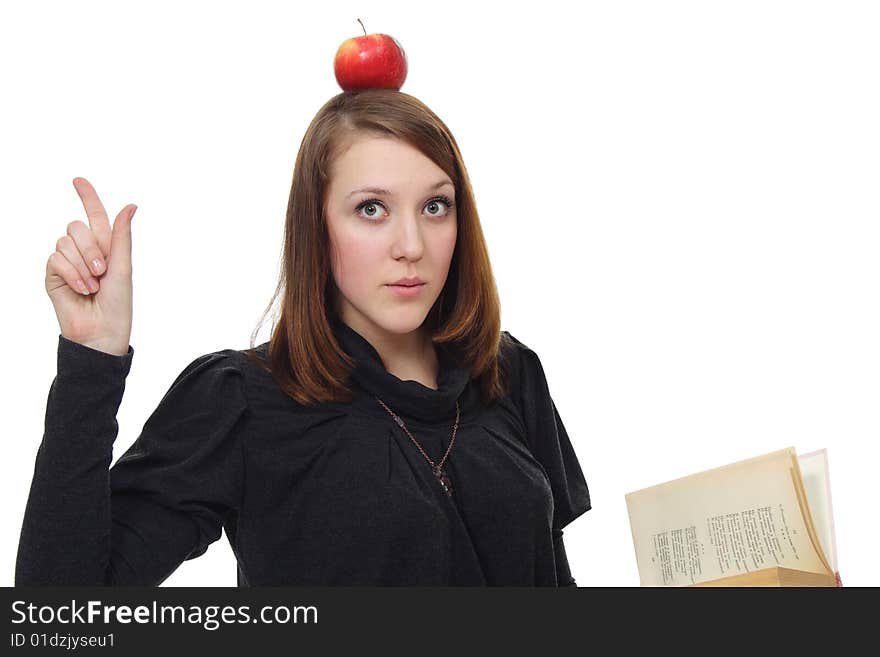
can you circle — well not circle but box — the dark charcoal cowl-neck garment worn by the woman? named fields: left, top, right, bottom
left=15, top=322, right=590, bottom=586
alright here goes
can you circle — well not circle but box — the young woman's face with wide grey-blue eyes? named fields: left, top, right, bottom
left=324, top=134, right=457, bottom=337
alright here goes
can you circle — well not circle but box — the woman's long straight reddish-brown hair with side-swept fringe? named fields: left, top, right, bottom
left=243, top=89, right=506, bottom=405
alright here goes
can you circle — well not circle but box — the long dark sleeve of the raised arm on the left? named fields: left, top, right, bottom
left=15, top=336, right=247, bottom=586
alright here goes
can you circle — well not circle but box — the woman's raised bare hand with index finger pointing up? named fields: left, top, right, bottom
left=46, top=178, right=137, bottom=356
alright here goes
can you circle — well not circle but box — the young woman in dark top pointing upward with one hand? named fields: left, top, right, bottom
left=15, top=89, right=590, bottom=586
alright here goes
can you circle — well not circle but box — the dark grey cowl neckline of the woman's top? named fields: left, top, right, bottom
left=330, top=318, right=470, bottom=422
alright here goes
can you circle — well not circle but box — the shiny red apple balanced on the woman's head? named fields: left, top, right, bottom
left=333, top=19, right=407, bottom=91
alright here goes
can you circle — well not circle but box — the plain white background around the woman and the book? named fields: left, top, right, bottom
left=0, top=0, right=880, bottom=586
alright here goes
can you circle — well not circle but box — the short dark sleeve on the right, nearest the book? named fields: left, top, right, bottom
left=504, top=331, right=591, bottom=532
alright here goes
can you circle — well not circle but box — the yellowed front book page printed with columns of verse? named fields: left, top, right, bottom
left=626, top=447, right=827, bottom=586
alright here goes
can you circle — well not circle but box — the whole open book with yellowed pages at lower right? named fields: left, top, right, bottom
left=626, top=447, right=841, bottom=586
